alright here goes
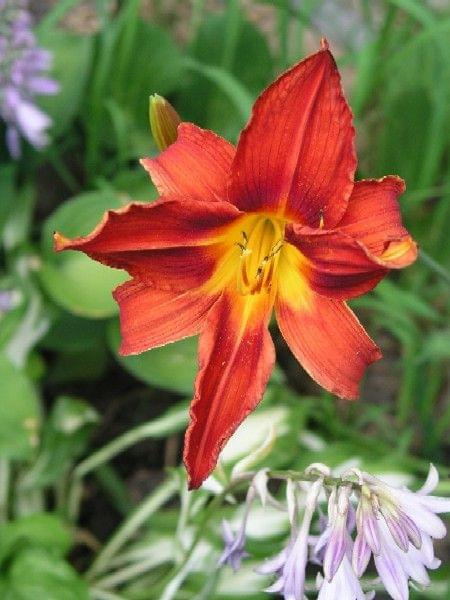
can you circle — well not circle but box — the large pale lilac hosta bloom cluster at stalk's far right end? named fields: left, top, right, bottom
left=353, top=465, right=450, bottom=600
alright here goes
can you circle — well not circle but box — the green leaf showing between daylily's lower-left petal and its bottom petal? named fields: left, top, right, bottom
left=108, top=321, right=198, bottom=394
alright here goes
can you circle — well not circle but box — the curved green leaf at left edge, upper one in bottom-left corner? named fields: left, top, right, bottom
left=0, top=513, right=72, bottom=563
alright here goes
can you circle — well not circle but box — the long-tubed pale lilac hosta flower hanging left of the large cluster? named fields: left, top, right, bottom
left=258, top=477, right=323, bottom=600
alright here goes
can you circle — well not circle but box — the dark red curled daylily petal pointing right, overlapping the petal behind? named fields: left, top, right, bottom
left=286, top=226, right=387, bottom=300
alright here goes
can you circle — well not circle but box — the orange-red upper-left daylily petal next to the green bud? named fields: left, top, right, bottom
left=141, top=123, right=235, bottom=200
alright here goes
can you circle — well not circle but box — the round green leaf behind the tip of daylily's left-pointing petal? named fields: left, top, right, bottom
left=39, top=192, right=128, bottom=318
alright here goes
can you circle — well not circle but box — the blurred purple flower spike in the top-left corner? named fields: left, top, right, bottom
left=0, top=0, right=58, bottom=158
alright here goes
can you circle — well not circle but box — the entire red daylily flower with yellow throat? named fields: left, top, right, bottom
left=55, top=41, right=417, bottom=488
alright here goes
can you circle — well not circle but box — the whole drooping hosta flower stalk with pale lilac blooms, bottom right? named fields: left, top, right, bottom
left=216, top=465, right=450, bottom=600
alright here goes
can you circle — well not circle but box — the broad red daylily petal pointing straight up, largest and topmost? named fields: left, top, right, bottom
left=229, top=45, right=356, bottom=228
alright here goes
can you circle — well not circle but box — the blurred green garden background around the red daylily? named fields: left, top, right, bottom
left=0, top=0, right=450, bottom=600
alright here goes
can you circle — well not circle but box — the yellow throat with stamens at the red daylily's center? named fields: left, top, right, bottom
left=235, top=216, right=284, bottom=296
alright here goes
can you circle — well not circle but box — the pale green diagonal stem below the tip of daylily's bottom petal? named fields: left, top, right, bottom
left=86, top=477, right=179, bottom=580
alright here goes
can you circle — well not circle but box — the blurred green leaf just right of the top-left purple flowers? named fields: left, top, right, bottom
left=39, top=29, right=94, bottom=137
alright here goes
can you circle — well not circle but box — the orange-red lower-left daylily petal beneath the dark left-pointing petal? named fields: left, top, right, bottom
left=113, top=280, right=217, bottom=354
